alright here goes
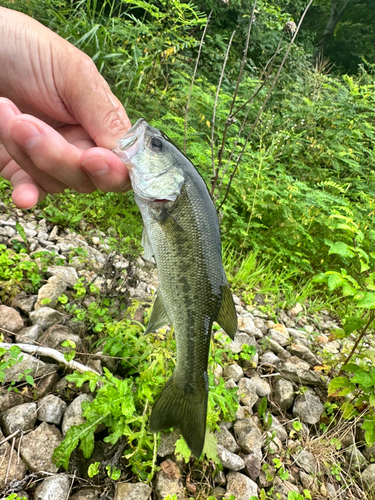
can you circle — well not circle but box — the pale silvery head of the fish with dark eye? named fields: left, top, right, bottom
left=113, top=118, right=185, bottom=204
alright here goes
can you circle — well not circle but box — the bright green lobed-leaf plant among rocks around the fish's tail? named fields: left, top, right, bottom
left=54, top=312, right=238, bottom=481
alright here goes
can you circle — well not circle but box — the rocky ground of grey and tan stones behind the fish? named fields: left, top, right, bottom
left=0, top=203, right=375, bottom=500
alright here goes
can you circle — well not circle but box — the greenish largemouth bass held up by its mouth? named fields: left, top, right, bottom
left=113, top=118, right=237, bottom=458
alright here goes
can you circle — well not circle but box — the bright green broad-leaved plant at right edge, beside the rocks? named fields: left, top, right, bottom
left=315, top=211, right=375, bottom=444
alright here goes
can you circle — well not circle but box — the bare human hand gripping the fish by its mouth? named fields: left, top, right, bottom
left=0, top=7, right=130, bottom=208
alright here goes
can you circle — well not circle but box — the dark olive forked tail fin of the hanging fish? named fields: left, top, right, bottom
left=150, top=375, right=208, bottom=458
